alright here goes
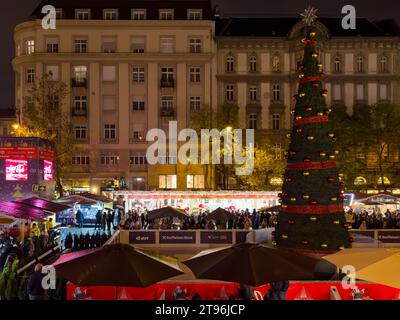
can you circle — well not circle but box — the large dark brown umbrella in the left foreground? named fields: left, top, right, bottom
left=53, top=244, right=183, bottom=287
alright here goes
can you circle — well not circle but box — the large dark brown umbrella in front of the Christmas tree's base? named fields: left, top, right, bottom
left=183, top=243, right=326, bottom=286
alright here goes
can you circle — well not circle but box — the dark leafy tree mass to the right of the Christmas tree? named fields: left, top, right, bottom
left=332, top=104, right=400, bottom=190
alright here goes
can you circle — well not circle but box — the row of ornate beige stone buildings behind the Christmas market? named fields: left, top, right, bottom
left=13, top=0, right=400, bottom=192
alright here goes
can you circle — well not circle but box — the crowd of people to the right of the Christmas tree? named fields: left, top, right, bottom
left=346, top=209, right=400, bottom=230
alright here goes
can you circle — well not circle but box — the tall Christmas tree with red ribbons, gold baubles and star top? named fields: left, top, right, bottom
left=275, top=9, right=352, bottom=254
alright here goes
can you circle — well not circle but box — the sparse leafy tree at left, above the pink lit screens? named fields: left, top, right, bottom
left=15, top=74, right=77, bottom=196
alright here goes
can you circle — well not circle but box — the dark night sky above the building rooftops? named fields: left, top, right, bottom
left=0, top=0, right=400, bottom=108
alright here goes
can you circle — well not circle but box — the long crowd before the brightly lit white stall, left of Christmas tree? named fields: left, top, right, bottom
left=119, top=209, right=278, bottom=230
